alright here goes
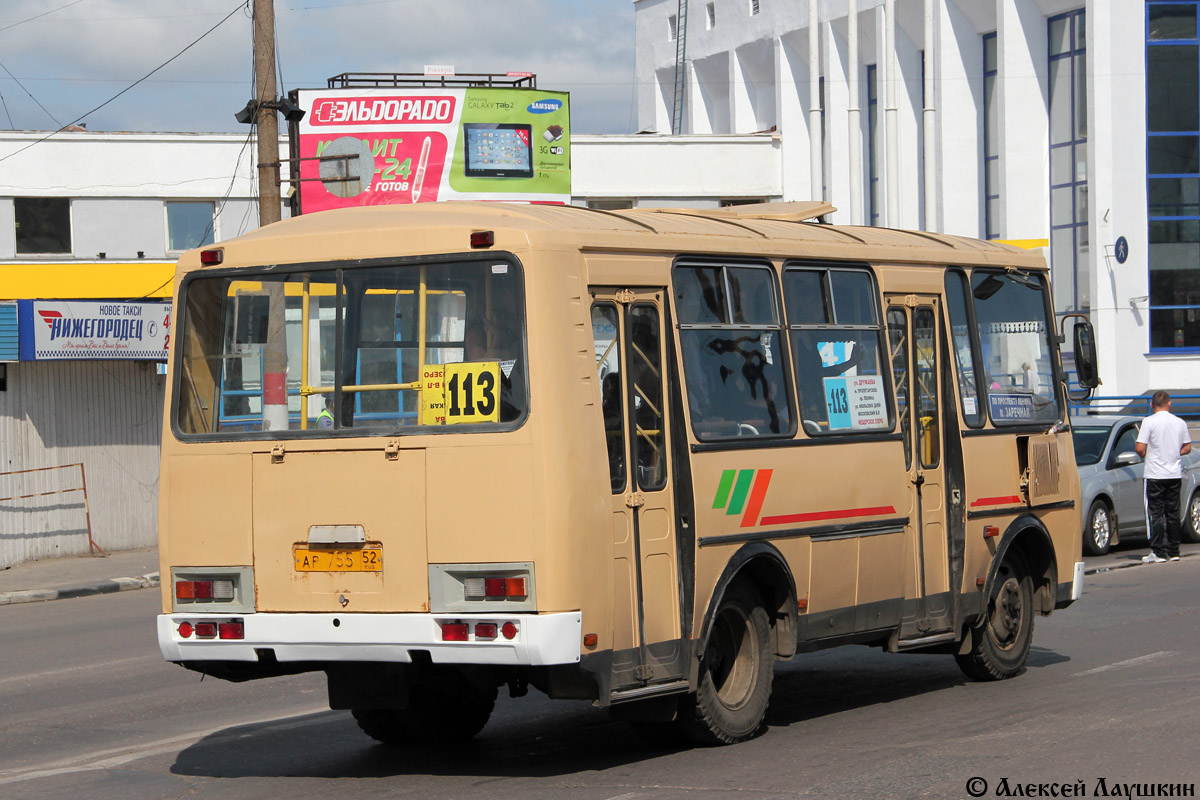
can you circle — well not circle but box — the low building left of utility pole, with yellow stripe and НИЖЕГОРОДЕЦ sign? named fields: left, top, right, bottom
left=0, top=131, right=272, bottom=569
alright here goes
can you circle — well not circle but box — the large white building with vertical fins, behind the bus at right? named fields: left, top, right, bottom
left=635, top=0, right=1200, bottom=395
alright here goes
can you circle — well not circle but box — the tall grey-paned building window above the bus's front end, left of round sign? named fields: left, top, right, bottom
left=1048, top=8, right=1091, bottom=313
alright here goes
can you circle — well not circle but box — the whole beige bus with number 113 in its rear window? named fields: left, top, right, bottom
left=157, top=203, right=1094, bottom=744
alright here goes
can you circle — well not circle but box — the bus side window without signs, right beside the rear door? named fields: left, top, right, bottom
left=674, top=265, right=793, bottom=440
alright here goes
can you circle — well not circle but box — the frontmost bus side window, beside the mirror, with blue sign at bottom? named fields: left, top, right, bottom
left=971, top=271, right=1062, bottom=426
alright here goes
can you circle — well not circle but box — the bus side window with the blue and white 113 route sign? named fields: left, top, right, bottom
left=784, top=267, right=893, bottom=435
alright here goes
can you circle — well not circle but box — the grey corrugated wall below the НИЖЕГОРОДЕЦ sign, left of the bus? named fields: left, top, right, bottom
left=0, top=361, right=166, bottom=569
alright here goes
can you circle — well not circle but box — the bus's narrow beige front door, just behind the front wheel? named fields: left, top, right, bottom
left=887, top=295, right=953, bottom=642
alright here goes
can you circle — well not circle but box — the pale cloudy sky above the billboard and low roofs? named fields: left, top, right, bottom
left=0, top=0, right=636, bottom=133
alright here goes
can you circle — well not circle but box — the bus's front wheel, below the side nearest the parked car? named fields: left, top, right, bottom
left=954, top=551, right=1033, bottom=680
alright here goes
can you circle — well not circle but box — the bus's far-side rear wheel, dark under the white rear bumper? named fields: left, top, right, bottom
left=352, top=686, right=496, bottom=745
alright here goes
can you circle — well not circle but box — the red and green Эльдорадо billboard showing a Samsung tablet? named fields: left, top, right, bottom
left=296, top=86, right=571, bottom=213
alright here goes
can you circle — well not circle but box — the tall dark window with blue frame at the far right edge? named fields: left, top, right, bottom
left=1146, top=2, right=1200, bottom=350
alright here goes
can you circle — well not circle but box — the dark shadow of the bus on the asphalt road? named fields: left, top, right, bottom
left=170, top=646, right=1070, bottom=781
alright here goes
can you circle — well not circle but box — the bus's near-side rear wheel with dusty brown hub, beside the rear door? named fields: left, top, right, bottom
left=678, top=583, right=774, bottom=745
